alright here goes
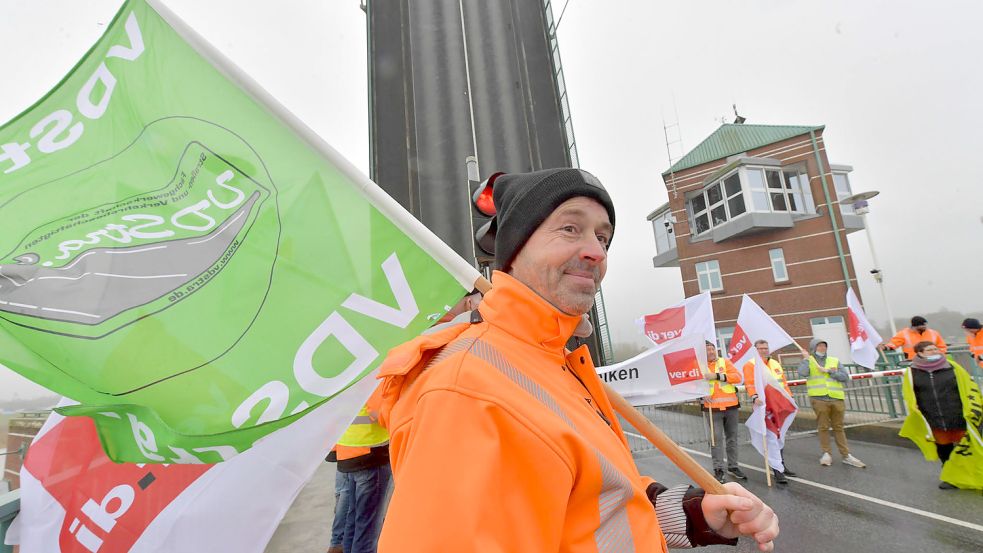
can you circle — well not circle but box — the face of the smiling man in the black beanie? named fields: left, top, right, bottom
left=509, top=196, right=614, bottom=315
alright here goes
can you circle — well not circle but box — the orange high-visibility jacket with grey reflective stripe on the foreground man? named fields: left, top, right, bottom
left=379, top=272, right=666, bottom=553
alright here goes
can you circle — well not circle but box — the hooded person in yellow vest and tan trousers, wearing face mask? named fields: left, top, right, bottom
left=799, top=338, right=867, bottom=468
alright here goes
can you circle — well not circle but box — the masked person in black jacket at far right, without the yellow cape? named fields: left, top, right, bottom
left=911, top=341, right=966, bottom=490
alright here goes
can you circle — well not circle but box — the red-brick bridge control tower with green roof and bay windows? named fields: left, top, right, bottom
left=648, top=124, right=863, bottom=360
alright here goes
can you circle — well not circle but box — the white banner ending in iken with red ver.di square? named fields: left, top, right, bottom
left=597, top=335, right=710, bottom=405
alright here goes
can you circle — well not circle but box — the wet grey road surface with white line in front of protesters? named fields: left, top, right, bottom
left=635, top=435, right=983, bottom=553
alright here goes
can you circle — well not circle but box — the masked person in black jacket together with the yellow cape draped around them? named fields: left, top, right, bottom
left=898, top=342, right=983, bottom=490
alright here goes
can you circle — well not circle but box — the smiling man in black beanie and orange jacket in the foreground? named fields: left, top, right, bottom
left=379, top=169, right=778, bottom=553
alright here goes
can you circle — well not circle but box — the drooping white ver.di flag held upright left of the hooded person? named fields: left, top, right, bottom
left=744, top=350, right=798, bottom=472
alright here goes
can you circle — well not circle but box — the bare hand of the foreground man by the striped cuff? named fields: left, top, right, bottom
left=703, top=482, right=778, bottom=551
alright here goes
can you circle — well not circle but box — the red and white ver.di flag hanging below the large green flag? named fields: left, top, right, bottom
left=7, top=375, right=377, bottom=553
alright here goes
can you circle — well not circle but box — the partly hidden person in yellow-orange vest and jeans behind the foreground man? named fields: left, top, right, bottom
left=328, top=407, right=392, bottom=553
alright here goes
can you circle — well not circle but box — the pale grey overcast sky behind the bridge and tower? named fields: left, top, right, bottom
left=0, top=0, right=983, bottom=399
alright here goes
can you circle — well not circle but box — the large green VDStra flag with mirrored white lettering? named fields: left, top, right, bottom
left=0, top=0, right=478, bottom=463
